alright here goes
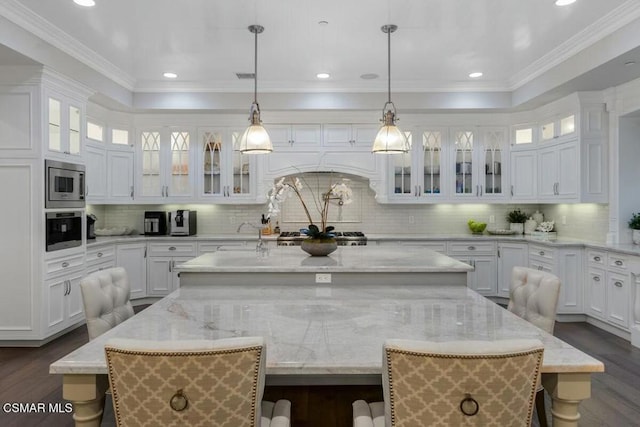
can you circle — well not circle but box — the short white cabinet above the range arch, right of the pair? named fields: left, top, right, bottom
left=322, top=124, right=380, bottom=152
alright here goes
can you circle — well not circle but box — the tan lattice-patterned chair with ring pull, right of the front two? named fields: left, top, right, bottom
left=353, top=339, right=544, bottom=427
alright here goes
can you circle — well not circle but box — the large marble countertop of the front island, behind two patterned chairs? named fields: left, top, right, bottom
left=50, top=283, right=604, bottom=378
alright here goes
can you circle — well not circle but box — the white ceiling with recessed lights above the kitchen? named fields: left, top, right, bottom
left=0, top=0, right=640, bottom=110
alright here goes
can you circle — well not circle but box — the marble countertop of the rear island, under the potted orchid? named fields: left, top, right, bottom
left=175, top=245, right=473, bottom=273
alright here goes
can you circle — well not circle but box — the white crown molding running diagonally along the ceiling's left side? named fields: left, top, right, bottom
left=0, top=0, right=136, bottom=91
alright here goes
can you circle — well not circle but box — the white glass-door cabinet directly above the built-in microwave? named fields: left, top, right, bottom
left=44, top=90, right=85, bottom=157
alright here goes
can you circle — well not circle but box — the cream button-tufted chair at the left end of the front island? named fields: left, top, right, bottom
left=80, top=267, right=134, bottom=340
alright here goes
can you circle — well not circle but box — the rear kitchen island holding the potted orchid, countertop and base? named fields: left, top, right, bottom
left=175, top=246, right=473, bottom=287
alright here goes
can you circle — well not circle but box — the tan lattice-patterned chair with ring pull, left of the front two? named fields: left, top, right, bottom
left=105, top=337, right=291, bottom=427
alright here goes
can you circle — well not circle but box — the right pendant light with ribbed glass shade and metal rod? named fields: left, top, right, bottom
left=371, top=24, right=409, bottom=154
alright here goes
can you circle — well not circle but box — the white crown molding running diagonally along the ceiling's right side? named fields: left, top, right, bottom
left=508, top=0, right=640, bottom=91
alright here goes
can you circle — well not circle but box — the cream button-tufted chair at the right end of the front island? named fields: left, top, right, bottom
left=507, top=267, right=560, bottom=427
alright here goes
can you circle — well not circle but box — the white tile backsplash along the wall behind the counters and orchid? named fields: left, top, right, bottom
left=87, top=177, right=609, bottom=242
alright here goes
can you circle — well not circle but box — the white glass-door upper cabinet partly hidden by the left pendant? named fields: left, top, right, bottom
left=197, top=128, right=264, bottom=203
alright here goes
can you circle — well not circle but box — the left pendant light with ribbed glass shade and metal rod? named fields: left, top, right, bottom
left=236, top=25, right=273, bottom=154
